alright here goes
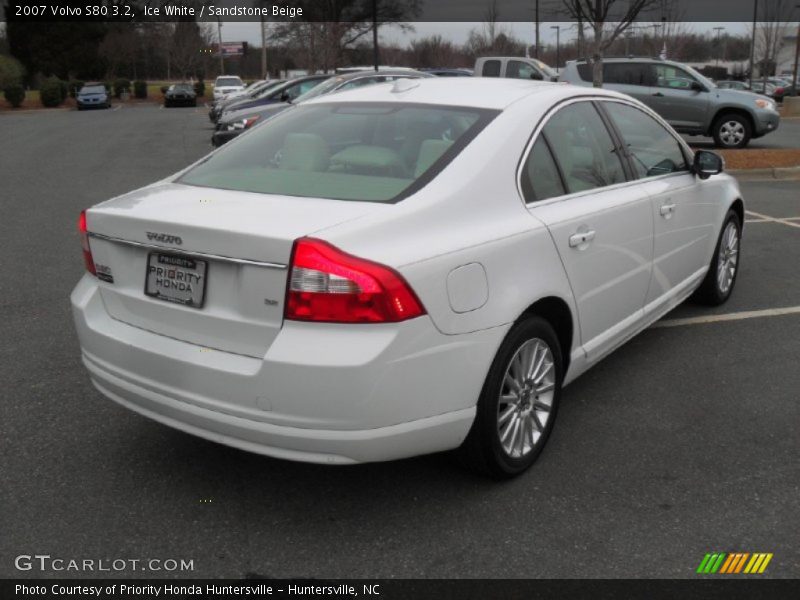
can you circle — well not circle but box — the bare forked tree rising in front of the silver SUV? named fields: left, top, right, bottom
left=562, top=0, right=663, bottom=87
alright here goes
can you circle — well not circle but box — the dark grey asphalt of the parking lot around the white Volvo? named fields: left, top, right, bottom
left=0, top=106, right=800, bottom=578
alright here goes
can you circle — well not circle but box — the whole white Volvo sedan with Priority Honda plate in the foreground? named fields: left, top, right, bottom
left=72, top=78, right=744, bottom=478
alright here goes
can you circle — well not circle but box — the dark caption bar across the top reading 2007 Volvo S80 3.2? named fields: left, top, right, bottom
left=0, top=0, right=800, bottom=24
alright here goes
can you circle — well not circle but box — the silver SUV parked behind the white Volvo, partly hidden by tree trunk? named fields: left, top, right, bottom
left=560, top=57, right=780, bottom=148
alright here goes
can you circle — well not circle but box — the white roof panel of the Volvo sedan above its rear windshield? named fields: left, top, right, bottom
left=303, top=77, right=626, bottom=110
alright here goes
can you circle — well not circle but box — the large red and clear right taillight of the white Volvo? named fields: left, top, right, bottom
left=285, top=238, right=425, bottom=323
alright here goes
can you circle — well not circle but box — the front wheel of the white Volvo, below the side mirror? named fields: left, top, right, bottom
left=694, top=210, right=742, bottom=306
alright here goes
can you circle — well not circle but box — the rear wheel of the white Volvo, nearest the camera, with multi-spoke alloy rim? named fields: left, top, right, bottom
left=459, top=316, right=563, bottom=479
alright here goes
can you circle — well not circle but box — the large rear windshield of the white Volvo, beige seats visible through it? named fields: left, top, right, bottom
left=179, top=103, right=498, bottom=202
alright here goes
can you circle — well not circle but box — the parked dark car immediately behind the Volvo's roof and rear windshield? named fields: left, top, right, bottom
left=211, top=69, right=433, bottom=146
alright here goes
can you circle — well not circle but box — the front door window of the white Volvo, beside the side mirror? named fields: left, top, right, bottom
left=603, top=102, right=689, bottom=178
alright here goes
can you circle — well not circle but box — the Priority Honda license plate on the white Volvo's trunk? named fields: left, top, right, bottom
left=144, top=252, right=209, bottom=309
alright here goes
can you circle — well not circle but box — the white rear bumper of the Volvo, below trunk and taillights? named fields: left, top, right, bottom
left=72, top=275, right=505, bottom=464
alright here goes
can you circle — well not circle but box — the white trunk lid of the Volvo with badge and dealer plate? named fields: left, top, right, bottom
left=87, top=183, right=381, bottom=357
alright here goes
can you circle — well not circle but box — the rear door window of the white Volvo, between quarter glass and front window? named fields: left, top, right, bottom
left=543, top=102, right=625, bottom=194
